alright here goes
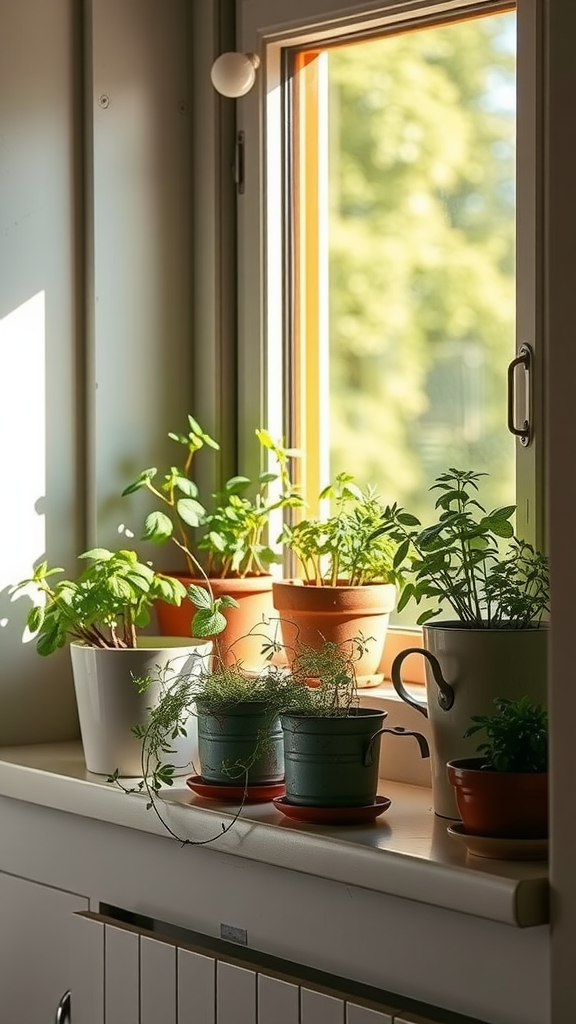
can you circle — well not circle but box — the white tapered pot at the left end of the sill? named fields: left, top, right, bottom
left=70, top=637, right=212, bottom=777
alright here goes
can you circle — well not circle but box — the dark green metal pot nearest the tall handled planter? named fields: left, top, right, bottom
left=281, top=708, right=386, bottom=807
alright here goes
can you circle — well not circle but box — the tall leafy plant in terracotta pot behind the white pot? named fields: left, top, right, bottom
left=123, top=416, right=301, bottom=670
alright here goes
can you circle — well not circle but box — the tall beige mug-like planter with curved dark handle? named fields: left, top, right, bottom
left=392, top=622, right=548, bottom=818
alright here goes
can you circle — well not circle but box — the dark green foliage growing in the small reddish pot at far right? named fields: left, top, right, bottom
left=464, top=696, right=548, bottom=772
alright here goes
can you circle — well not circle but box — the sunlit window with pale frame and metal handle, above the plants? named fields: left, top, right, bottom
left=234, top=0, right=544, bottom=598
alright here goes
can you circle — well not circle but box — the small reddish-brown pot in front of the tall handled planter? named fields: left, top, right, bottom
left=446, top=758, right=548, bottom=839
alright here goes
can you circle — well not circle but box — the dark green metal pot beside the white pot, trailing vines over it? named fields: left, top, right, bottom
left=196, top=700, right=284, bottom=785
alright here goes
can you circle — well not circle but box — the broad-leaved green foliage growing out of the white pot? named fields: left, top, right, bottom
left=11, top=548, right=190, bottom=655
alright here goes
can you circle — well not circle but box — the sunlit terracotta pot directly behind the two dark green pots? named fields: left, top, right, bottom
left=272, top=580, right=396, bottom=686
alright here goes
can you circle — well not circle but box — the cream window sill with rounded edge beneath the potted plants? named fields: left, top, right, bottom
left=0, top=742, right=548, bottom=928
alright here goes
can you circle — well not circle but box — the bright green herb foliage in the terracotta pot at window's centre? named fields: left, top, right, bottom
left=281, top=473, right=400, bottom=587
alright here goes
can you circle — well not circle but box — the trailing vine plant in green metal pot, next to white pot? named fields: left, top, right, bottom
left=124, top=633, right=289, bottom=846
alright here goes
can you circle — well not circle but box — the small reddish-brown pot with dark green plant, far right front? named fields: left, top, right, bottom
left=447, top=697, right=548, bottom=839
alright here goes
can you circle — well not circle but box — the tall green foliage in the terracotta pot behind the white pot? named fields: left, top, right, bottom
left=123, top=416, right=301, bottom=579
